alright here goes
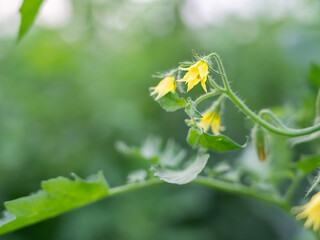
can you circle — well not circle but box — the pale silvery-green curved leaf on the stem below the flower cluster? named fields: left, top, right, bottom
left=152, top=154, right=209, bottom=185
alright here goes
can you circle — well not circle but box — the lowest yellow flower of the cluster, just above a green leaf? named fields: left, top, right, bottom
left=197, top=112, right=221, bottom=135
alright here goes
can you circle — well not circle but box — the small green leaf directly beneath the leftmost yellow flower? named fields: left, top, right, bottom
left=153, top=92, right=187, bottom=112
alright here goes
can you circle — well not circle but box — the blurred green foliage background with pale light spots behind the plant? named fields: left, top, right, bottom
left=0, top=0, right=320, bottom=240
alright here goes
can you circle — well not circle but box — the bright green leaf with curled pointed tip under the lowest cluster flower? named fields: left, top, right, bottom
left=187, top=128, right=247, bottom=152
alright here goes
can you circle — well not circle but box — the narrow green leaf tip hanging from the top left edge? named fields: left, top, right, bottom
left=18, top=0, right=43, bottom=41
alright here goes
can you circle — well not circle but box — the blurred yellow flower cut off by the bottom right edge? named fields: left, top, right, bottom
left=292, top=192, right=320, bottom=231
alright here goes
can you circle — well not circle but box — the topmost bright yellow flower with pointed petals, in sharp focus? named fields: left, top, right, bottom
left=178, top=60, right=209, bottom=92
